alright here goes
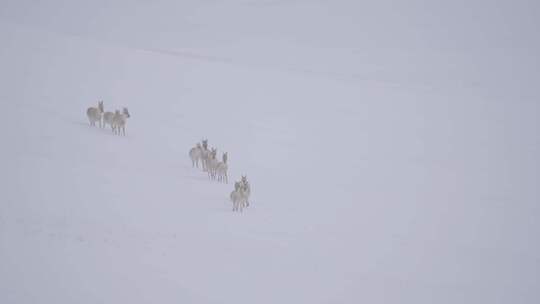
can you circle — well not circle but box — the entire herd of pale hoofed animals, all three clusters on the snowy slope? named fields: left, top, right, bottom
left=86, top=101, right=251, bottom=212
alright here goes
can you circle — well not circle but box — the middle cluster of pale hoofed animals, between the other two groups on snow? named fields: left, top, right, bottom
left=189, top=139, right=229, bottom=183
